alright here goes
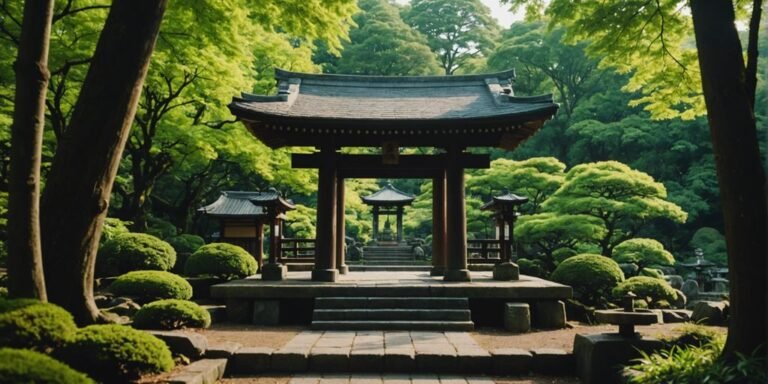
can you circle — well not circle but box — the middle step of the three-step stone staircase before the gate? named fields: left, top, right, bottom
left=312, top=308, right=472, bottom=321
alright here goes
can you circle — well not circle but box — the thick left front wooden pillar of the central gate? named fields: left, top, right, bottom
left=312, top=146, right=339, bottom=282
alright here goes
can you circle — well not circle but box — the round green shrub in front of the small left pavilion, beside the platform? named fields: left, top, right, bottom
left=184, top=243, right=257, bottom=280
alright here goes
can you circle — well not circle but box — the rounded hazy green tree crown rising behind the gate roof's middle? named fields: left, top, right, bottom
left=324, top=0, right=440, bottom=76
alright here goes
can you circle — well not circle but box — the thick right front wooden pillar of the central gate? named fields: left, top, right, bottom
left=444, top=146, right=471, bottom=281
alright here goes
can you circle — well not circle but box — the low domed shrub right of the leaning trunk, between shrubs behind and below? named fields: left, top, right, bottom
left=109, top=271, right=192, bottom=303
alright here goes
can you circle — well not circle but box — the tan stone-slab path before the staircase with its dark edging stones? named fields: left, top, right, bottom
left=160, top=331, right=575, bottom=383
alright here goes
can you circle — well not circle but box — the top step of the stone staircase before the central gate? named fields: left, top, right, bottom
left=315, top=297, right=469, bottom=310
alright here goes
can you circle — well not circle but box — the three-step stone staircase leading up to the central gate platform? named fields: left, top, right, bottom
left=312, top=297, right=474, bottom=331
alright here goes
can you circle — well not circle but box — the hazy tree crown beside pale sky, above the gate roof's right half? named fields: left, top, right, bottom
left=403, top=0, right=499, bottom=75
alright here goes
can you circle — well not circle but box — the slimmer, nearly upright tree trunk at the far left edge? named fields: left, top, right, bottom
left=8, top=0, right=53, bottom=301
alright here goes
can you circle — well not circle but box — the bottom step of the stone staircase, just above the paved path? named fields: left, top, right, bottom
left=312, top=320, right=475, bottom=332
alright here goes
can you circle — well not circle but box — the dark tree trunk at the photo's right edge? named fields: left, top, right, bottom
left=690, top=0, right=768, bottom=357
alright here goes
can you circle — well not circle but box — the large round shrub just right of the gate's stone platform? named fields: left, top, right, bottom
left=550, top=253, right=624, bottom=304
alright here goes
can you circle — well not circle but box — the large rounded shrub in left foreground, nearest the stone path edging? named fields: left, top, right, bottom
left=57, top=324, right=174, bottom=383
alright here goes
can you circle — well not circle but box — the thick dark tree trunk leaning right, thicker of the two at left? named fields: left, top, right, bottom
left=42, top=0, right=167, bottom=325
